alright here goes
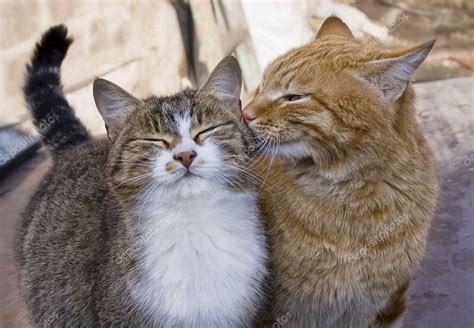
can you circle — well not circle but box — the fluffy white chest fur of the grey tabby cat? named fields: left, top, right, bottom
left=132, top=188, right=267, bottom=327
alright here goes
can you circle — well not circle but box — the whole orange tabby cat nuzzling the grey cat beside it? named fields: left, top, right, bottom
left=243, top=17, right=438, bottom=328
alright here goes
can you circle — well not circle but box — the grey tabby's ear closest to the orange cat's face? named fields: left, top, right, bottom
left=199, top=56, right=242, bottom=112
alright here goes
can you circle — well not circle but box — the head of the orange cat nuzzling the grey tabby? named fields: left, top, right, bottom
left=242, top=17, right=434, bottom=169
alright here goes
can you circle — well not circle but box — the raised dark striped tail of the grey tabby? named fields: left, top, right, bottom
left=23, top=25, right=90, bottom=157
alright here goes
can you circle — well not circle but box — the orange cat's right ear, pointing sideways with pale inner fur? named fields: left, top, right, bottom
left=358, top=40, right=435, bottom=100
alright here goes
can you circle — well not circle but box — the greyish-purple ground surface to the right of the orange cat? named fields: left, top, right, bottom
left=405, top=78, right=474, bottom=328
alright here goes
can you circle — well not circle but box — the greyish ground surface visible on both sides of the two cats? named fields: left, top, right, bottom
left=0, top=78, right=474, bottom=328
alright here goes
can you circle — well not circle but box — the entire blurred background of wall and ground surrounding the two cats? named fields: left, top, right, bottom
left=0, top=0, right=474, bottom=328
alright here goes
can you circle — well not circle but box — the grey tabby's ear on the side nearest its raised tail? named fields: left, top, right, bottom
left=93, top=79, right=142, bottom=134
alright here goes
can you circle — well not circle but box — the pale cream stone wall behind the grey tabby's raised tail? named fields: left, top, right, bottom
left=0, top=0, right=187, bottom=134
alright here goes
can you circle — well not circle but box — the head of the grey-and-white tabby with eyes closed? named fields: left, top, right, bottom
left=94, top=57, right=252, bottom=205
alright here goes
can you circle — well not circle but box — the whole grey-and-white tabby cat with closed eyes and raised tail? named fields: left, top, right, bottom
left=16, top=25, right=267, bottom=328
